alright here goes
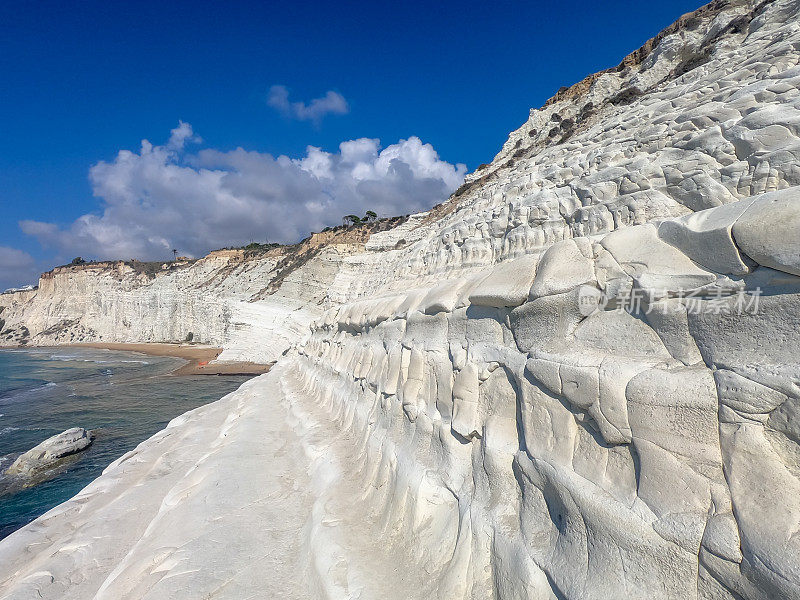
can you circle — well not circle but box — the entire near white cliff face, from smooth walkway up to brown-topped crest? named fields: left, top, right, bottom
left=292, top=2, right=800, bottom=599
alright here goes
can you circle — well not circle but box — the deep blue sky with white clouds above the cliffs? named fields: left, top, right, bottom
left=0, top=0, right=698, bottom=287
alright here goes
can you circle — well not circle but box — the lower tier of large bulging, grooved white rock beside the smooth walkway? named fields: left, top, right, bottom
left=290, top=190, right=800, bottom=599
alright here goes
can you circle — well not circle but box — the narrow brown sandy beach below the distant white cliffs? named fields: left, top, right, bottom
left=65, top=342, right=272, bottom=376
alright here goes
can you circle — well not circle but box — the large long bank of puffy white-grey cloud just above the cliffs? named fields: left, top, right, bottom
left=20, top=123, right=466, bottom=260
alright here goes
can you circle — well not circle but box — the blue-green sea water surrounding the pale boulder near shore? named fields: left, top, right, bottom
left=0, top=348, right=247, bottom=538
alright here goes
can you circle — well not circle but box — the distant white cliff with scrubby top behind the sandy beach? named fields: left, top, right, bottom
left=0, top=236, right=363, bottom=363
